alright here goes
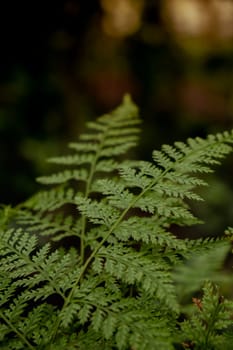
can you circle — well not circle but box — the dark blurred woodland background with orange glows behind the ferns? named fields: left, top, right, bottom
left=0, top=0, right=233, bottom=234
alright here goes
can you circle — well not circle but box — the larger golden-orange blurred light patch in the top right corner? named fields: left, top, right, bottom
left=163, top=0, right=233, bottom=40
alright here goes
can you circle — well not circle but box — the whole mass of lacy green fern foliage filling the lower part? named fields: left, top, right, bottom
left=0, top=96, right=233, bottom=350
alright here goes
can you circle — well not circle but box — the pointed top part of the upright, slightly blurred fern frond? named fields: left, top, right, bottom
left=38, top=96, right=140, bottom=189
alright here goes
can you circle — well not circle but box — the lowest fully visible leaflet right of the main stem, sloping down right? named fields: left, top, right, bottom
left=93, top=243, right=177, bottom=310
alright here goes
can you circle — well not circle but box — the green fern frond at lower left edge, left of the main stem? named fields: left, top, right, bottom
left=0, top=230, right=82, bottom=349
